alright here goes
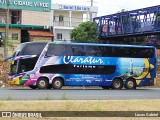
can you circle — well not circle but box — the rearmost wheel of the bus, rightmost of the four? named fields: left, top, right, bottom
left=125, top=79, right=136, bottom=89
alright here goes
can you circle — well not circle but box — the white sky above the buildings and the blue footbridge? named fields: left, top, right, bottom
left=52, top=0, right=160, bottom=16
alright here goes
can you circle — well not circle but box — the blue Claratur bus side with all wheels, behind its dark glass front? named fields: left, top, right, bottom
left=17, top=42, right=156, bottom=89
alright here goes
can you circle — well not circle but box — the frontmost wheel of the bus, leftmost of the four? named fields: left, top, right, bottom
left=37, top=78, right=48, bottom=89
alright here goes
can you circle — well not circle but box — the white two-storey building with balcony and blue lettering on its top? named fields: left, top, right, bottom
left=51, top=4, right=98, bottom=41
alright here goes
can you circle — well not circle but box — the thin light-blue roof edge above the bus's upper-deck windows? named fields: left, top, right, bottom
left=50, top=41, right=154, bottom=48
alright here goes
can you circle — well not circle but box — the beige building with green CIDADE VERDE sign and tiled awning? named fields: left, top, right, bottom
left=0, top=0, right=53, bottom=55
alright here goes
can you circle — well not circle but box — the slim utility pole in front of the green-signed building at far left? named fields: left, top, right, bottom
left=3, top=0, right=10, bottom=58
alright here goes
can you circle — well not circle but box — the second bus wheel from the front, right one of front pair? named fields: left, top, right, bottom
left=52, top=78, right=63, bottom=89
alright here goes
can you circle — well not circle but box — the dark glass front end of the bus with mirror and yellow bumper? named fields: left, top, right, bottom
left=4, top=42, right=47, bottom=88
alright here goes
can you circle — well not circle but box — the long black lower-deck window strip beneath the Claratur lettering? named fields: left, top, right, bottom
left=40, top=64, right=116, bottom=74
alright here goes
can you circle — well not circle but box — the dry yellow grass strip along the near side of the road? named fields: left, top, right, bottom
left=0, top=100, right=160, bottom=120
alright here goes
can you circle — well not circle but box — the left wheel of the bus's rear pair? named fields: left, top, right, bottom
left=112, top=78, right=123, bottom=89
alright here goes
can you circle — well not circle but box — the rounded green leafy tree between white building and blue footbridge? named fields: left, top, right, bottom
left=71, top=21, right=98, bottom=43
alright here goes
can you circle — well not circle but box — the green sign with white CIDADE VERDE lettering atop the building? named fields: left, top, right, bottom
left=0, top=0, right=51, bottom=12
